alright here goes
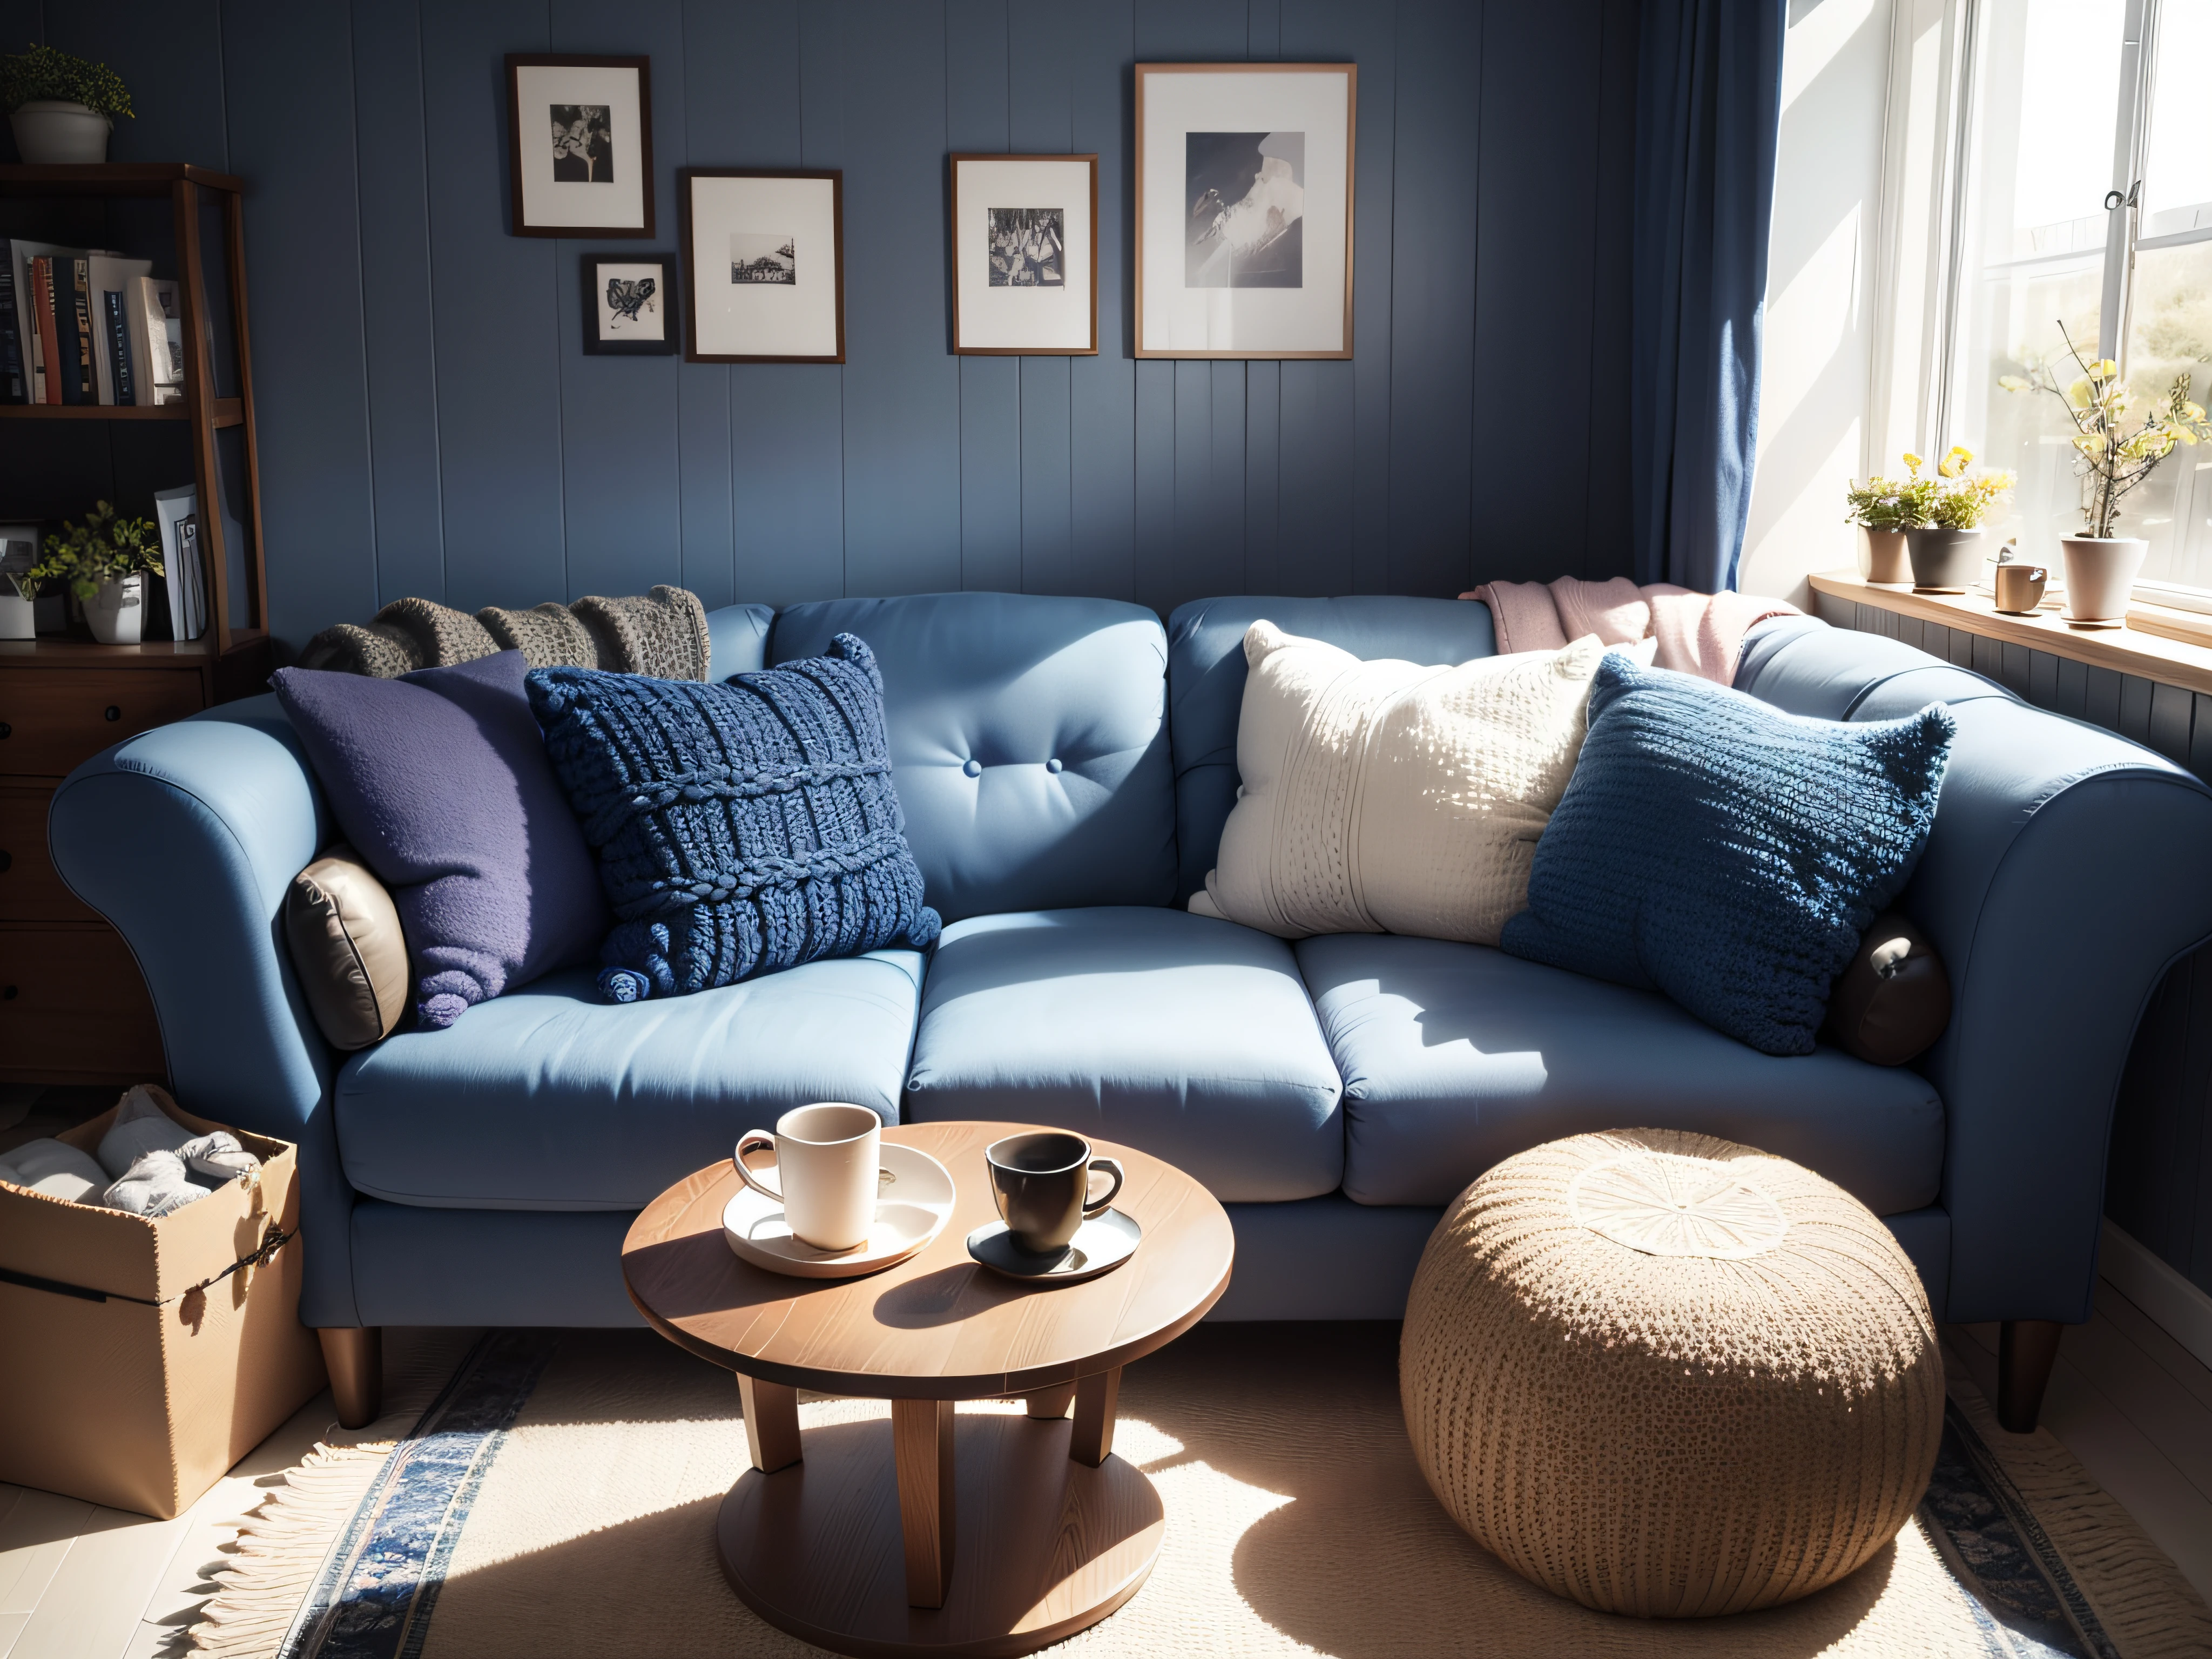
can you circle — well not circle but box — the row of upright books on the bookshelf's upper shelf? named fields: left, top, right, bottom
left=0, top=237, right=184, bottom=405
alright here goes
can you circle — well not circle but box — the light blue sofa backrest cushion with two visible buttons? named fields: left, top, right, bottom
left=767, top=593, right=1177, bottom=922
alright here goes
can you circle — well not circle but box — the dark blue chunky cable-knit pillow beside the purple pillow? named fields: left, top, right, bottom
left=529, top=632, right=938, bottom=1002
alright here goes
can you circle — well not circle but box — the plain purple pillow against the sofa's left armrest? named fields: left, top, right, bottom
left=274, top=650, right=608, bottom=1029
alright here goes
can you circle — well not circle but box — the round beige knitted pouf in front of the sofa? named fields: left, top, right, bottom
left=1398, top=1130, right=1944, bottom=1617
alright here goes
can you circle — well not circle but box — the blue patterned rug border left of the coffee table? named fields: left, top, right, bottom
left=281, top=1332, right=559, bottom=1659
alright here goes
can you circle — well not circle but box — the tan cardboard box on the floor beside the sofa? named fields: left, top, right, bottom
left=0, top=1088, right=323, bottom=1520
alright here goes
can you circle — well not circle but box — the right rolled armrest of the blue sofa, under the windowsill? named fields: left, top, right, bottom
left=1893, top=697, right=2212, bottom=1323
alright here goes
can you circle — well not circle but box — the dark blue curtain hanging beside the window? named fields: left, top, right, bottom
left=1628, top=0, right=1788, bottom=593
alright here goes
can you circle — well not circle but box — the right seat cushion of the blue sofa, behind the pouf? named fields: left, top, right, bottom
left=1296, top=934, right=1944, bottom=1215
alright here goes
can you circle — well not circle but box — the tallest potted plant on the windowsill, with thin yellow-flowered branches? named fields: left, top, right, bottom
left=1998, top=323, right=2212, bottom=628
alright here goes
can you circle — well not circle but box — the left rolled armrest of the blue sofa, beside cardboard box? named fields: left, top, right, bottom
left=46, top=697, right=359, bottom=1325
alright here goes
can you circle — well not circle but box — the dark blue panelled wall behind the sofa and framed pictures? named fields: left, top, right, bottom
left=0, top=0, right=1637, bottom=663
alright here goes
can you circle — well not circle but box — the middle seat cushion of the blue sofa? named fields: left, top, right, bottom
left=907, top=907, right=1345, bottom=1203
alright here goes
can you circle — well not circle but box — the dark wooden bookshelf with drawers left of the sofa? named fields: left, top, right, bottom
left=0, top=164, right=274, bottom=1084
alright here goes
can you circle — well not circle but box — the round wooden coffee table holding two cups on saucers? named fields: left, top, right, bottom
left=622, top=1124, right=1235, bottom=1655
